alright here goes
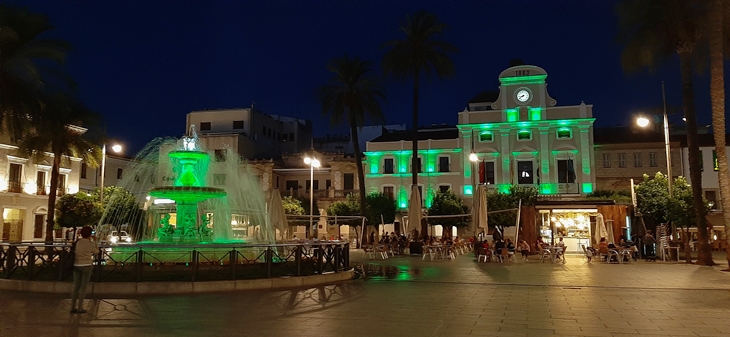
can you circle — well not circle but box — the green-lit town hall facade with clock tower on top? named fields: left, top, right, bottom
left=457, top=65, right=595, bottom=195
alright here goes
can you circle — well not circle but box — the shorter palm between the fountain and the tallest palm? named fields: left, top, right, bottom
left=319, top=55, right=385, bottom=236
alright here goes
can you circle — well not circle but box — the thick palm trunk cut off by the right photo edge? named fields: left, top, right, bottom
left=709, top=0, right=730, bottom=271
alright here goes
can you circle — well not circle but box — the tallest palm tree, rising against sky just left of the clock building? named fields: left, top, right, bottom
left=382, top=11, right=457, bottom=186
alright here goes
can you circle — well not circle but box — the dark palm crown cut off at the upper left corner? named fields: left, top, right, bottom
left=0, top=5, right=73, bottom=139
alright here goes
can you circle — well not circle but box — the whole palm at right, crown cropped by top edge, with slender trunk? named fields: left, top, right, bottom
left=616, top=0, right=714, bottom=265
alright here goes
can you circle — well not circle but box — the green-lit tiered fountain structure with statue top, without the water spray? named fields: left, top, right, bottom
left=149, top=137, right=226, bottom=243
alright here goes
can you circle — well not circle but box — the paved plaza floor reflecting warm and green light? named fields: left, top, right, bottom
left=0, top=251, right=730, bottom=337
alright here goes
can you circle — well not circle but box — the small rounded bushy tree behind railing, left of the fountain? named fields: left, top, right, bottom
left=56, top=193, right=101, bottom=229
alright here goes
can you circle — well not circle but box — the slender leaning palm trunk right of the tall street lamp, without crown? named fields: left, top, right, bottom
left=679, top=48, right=715, bottom=266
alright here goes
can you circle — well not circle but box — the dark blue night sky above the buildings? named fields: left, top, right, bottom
left=14, top=0, right=710, bottom=150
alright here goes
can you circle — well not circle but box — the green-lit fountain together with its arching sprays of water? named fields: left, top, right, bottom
left=100, top=129, right=275, bottom=244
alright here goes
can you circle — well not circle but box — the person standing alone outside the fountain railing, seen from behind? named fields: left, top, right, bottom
left=71, top=226, right=99, bottom=314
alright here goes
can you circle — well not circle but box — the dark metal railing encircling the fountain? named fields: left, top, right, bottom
left=0, top=242, right=350, bottom=282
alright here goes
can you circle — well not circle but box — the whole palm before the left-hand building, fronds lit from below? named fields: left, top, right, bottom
left=19, top=94, right=101, bottom=242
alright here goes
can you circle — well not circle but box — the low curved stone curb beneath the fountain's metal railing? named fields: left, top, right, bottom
left=0, top=269, right=355, bottom=296
